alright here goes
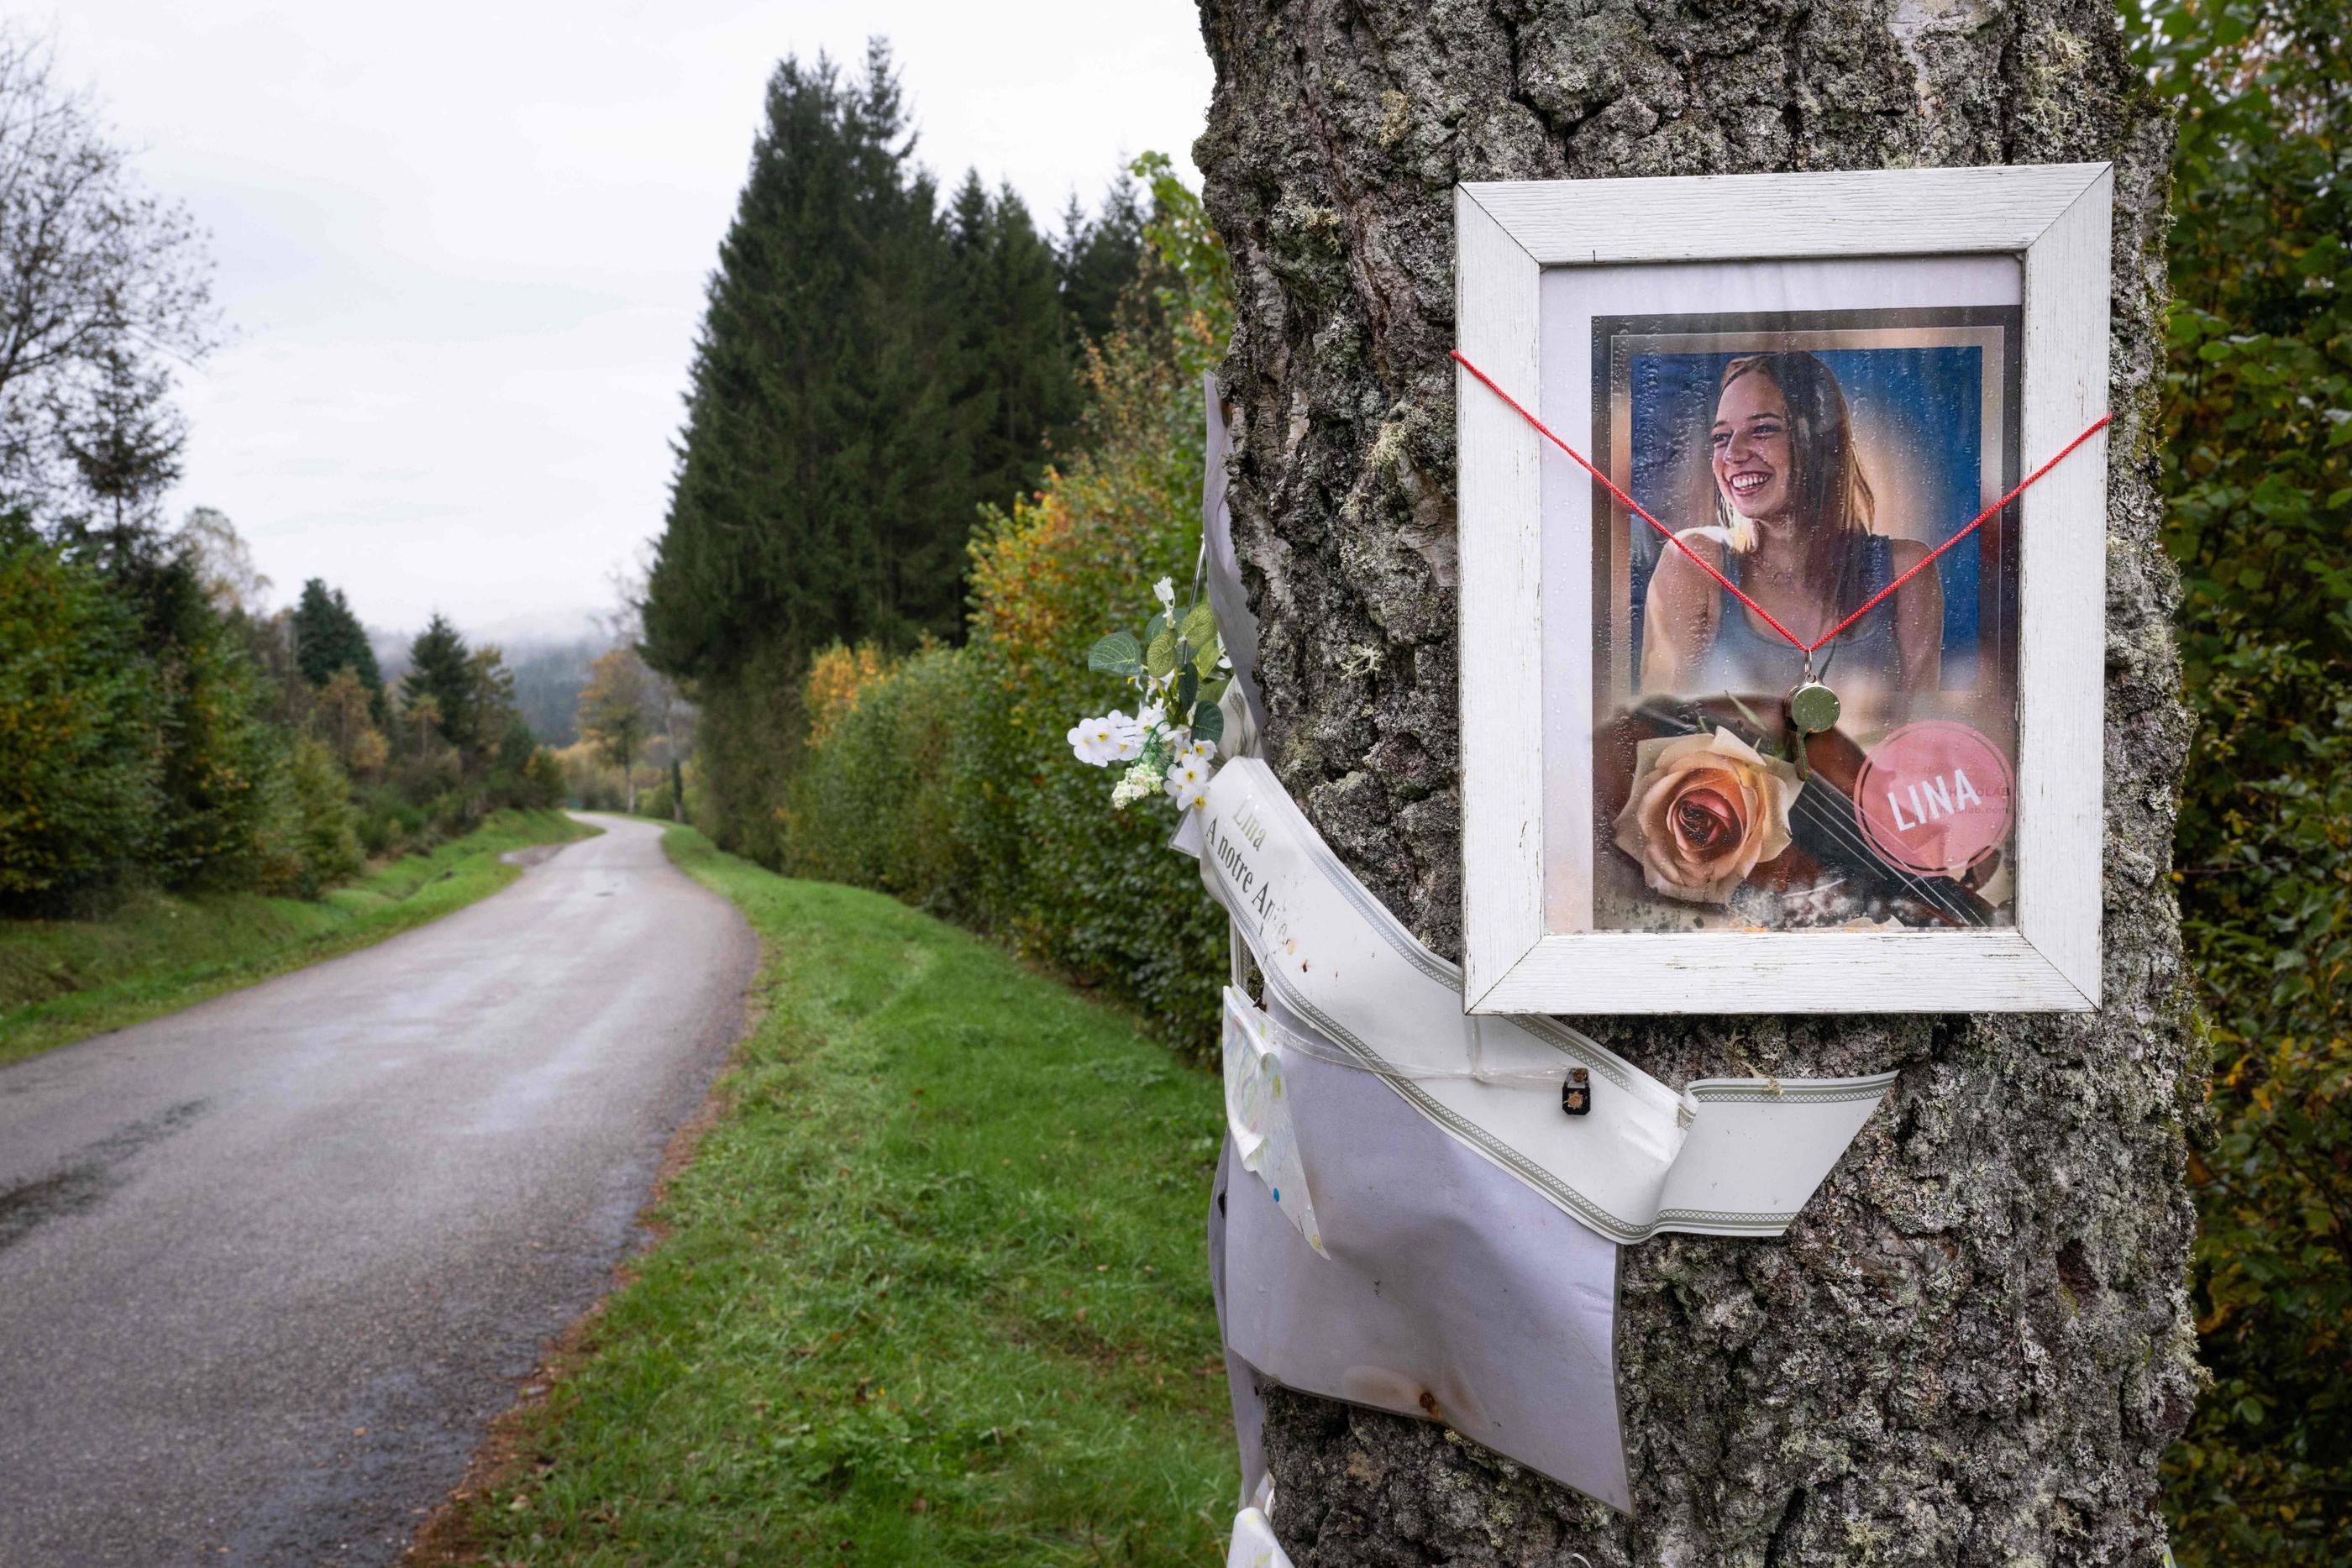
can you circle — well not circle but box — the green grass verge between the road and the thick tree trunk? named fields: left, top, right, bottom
left=470, top=827, right=1237, bottom=1568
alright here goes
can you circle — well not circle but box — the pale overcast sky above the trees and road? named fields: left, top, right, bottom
left=41, top=0, right=1209, bottom=639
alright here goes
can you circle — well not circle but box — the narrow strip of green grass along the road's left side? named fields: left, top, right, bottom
left=0, top=811, right=595, bottom=1062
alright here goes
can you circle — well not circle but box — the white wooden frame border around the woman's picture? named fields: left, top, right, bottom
left=1456, top=165, right=2112, bottom=1013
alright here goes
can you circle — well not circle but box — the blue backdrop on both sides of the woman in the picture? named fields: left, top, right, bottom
left=1628, top=348, right=1985, bottom=684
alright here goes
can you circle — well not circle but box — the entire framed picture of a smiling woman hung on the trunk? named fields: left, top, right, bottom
left=1456, top=165, right=2112, bottom=1013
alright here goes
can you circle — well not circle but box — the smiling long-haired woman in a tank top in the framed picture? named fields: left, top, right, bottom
left=1641, top=353, right=1943, bottom=721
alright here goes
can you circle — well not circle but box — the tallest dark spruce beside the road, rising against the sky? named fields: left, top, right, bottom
left=644, top=40, right=971, bottom=677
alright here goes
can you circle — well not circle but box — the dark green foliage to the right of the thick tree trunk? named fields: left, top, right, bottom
left=2124, top=0, right=2352, bottom=1568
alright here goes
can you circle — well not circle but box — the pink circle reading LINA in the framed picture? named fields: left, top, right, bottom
left=1853, top=720, right=2018, bottom=874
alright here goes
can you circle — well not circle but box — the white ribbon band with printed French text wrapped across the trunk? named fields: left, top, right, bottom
left=1202, top=757, right=1896, bottom=1241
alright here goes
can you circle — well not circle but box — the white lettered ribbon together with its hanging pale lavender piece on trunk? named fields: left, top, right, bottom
left=1200, top=759, right=1893, bottom=1509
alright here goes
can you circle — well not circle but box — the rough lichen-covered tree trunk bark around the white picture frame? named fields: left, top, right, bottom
left=1197, top=0, right=2202, bottom=1568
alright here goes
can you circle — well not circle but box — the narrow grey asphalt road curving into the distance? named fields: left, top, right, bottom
left=0, top=818, right=758, bottom=1568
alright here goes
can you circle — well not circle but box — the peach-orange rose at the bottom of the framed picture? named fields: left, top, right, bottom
left=1616, top=729, right=1797, bottom=903
